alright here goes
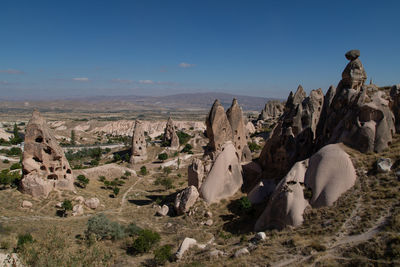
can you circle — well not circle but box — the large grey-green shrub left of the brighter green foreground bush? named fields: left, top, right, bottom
left=85, top=213, right=125, bottom=240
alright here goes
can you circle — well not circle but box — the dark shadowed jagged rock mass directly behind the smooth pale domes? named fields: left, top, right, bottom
left=260, top=86, right=324, bottom=178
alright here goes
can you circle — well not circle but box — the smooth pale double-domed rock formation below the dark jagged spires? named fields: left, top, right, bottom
left=255, top=144, right=356, bottom=231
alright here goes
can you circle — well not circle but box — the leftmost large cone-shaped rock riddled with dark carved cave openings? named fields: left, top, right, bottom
left=21, top=111, right=74, bottom=197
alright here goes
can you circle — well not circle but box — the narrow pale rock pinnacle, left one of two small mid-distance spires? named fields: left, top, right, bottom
left=130, top=120, right=147, bottom=164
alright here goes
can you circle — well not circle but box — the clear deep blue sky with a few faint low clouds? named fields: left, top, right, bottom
left=0, top=0, right=400, bottom=98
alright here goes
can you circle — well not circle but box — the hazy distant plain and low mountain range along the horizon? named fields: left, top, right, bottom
left=0, top=92, right=282, bottom=111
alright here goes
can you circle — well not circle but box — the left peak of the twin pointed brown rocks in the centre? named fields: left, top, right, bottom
left=206, top=100, right=233, bottom=151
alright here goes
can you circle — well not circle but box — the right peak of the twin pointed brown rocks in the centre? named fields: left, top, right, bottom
left=226, top=98, right=251, bottom=161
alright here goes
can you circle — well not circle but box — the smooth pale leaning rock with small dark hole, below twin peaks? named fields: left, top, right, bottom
left=200, top=142, right=243, bottom=203
